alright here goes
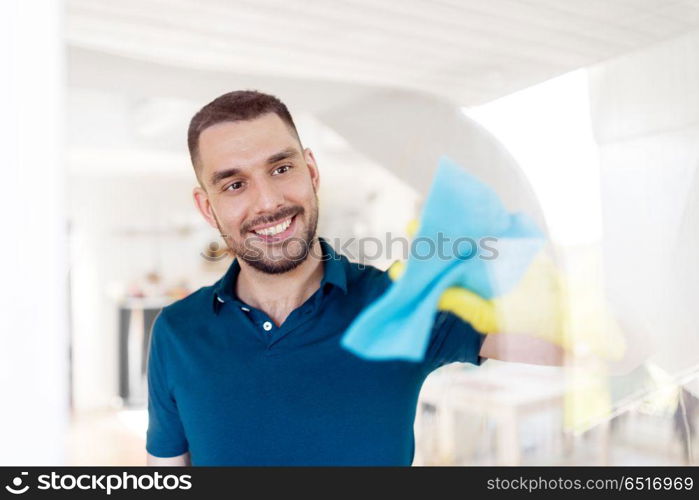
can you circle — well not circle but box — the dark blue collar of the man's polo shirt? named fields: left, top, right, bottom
left=212, top=236, right=348, bottom=313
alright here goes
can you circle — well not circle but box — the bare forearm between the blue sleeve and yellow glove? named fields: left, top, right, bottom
left=479, top=333, right=565, bottom=366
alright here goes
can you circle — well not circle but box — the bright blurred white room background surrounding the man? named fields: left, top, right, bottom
left=0, top=0, right=699, bottom=465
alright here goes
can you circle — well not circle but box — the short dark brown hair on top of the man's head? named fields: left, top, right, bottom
left=187, top=90, right=301, bottom=176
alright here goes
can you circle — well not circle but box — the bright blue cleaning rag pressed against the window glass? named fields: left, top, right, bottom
left=341, top=156, right=545, bottom=362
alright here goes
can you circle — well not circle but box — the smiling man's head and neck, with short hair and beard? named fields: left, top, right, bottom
left=189, top=106, right=323, bottom=325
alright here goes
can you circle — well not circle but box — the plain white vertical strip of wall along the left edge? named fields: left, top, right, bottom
left=0, top=0, right=69, bottom=465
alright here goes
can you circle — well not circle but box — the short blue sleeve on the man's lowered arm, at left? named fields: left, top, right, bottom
left=146, top=311, right=189, bottom=457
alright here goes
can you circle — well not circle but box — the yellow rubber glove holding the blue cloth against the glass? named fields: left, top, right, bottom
left=388, top=220, right=625, bottom=433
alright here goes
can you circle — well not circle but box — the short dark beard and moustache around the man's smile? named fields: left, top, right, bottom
left=216, top=194, right=318, bottom=274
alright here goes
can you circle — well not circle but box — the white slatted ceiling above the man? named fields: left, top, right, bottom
left=67, top=0, right=699, bottom=105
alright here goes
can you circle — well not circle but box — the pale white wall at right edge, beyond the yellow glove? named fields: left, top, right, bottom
left=589, top=31, right=699, bottom=380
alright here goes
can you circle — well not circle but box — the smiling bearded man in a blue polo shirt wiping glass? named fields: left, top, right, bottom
left=146, top=91, right=564, bottom=465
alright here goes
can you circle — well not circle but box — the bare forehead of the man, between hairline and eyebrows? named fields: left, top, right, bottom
left=199, top=113, right=300, bottom=173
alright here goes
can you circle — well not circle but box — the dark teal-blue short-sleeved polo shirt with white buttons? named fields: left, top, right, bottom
left=146, top=237, right=485, bottom=466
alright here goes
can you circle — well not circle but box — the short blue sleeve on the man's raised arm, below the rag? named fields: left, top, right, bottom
left=424, top=311, right=486, bottom=372
